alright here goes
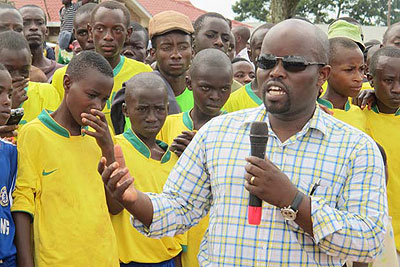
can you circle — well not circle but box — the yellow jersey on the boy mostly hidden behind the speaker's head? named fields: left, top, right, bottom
left=222, top=83, right=263, bottom=112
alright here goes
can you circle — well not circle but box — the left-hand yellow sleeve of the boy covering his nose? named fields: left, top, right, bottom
left=11, top=124, right=40, bottom=217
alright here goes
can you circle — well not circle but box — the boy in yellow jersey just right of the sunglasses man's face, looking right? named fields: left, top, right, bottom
left=318, top=37, right=367, bottom=132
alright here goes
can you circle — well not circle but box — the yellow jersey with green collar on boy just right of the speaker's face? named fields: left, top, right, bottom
left=317, top=98, right=368, bottom=134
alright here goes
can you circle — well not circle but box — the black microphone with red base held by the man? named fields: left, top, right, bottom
left=248, top=121, right=268, bottom=225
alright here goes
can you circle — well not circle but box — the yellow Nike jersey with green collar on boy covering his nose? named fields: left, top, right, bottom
left=12, top=111, right=119, bottom=267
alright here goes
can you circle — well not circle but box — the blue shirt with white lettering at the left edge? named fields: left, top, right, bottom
left=0, top=140, right=17, bottom=259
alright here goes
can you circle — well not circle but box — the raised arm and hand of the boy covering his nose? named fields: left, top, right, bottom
left=81, top=109, right=124, bottom=215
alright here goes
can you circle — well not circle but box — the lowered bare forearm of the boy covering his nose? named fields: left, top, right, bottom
left=12, top=212, right=34, bottom=267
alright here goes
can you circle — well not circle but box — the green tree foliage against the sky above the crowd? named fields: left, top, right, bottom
left=232, top=0, right=400, bottom=25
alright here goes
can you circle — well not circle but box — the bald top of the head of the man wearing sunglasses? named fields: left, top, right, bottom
left=261, top=19, right=329, bottom=63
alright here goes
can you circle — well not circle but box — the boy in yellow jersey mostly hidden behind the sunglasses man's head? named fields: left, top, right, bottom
left=223, top=23, right=273, bottom=112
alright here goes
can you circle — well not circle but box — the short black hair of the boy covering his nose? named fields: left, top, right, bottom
left=65, top=51, right=114, bottom=81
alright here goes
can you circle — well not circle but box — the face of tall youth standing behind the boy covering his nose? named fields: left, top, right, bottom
left=89, top=7, right=130, bottom=58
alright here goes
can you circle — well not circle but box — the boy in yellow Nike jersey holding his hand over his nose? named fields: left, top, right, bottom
left=11, top=51, right=118, bottom=267
